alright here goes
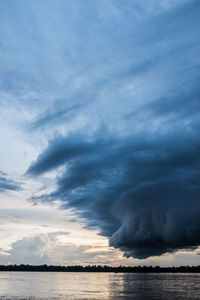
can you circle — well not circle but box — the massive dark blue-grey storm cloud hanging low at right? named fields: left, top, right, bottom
left=30, top=122, right=200, bottom=258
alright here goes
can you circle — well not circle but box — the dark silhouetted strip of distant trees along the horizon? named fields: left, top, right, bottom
left=0, top=264, right=200, bottom=273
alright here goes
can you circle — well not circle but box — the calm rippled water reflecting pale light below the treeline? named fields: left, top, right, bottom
left=0, top=272, right=200, bottom=300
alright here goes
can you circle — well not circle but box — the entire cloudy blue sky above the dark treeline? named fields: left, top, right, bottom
left=0, top=0, right=200, bottom=266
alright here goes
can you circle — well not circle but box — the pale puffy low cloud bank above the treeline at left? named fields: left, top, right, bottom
left=0, top=232, right=119, bottom=265
